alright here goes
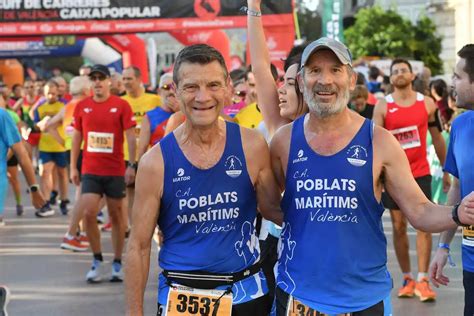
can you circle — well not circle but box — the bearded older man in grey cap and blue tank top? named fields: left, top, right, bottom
left=270, top=38, right=474, bottom=316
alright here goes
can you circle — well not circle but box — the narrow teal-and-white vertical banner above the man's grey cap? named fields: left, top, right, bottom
left=323, top=0, right=344, bottom=42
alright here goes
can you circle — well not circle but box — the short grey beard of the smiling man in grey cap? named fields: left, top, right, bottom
left=303, top=84, right=350, bottom=118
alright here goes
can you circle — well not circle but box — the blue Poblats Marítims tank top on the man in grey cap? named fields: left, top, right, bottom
left=277, top=116, right=392, bottom=314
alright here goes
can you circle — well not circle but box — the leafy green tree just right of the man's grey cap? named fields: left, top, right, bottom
left=344, top=6, right=442, bottom=75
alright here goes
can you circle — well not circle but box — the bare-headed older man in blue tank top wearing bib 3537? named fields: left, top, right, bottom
left=125, top=45, right=283, bottom=316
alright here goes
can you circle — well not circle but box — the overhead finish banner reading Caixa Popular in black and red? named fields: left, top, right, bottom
left=0, top=0, right=293, bottom=36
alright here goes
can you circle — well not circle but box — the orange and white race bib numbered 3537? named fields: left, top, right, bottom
left=165, top=285, right=232, bottom=316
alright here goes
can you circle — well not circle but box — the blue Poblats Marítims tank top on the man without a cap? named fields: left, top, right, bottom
left=158, top=122, right=267, bottom=304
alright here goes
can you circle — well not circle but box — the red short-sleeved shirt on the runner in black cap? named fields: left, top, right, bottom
left=74, top=95, right=136, bottom=176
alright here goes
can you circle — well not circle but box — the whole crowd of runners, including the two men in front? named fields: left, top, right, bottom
left=0, top=0, right=474, bottom=316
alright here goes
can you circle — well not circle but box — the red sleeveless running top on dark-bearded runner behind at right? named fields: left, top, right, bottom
left=385, top=93, right=430, bottom=178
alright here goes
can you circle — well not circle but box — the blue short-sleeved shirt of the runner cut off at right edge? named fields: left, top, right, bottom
left=444, top=111, right=474, bottom=273
